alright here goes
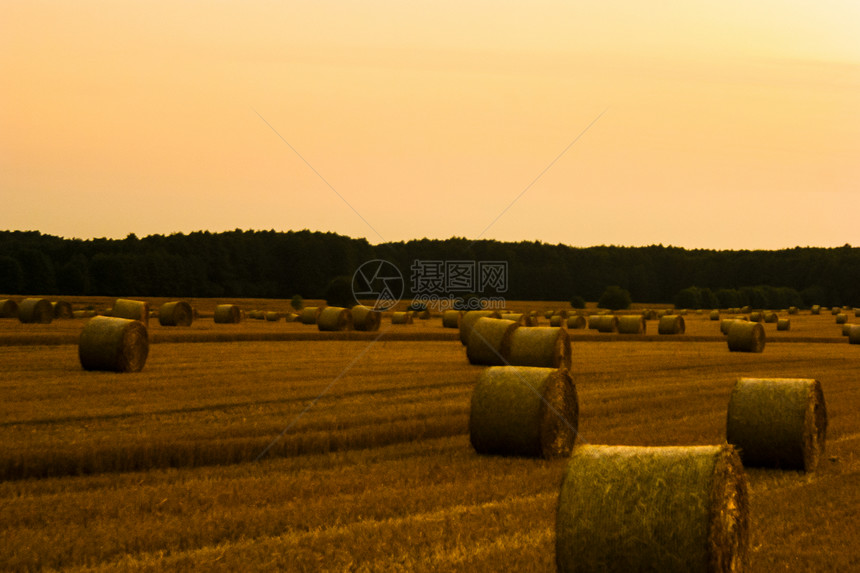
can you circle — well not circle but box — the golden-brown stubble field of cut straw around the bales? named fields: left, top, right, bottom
left=0, top=302, right=860, bottom=572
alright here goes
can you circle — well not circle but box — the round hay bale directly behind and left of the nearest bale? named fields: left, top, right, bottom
left=469, top=366, right=579, bottom=459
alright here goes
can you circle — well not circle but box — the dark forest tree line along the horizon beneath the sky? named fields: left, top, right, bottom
left=0, top=229, right=860, bottom=308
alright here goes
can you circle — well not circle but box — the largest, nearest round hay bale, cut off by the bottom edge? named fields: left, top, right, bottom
left=556, top=445, right=749, bottom=573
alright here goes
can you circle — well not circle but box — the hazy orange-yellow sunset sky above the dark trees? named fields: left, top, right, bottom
left=0, top=0, right=860, bottom=249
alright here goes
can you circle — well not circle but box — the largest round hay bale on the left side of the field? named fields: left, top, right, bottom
left=78, top=316, right=149, bottom=372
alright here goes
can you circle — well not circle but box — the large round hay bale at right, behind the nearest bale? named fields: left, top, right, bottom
left=726, top=378, right=827, bottom=471
